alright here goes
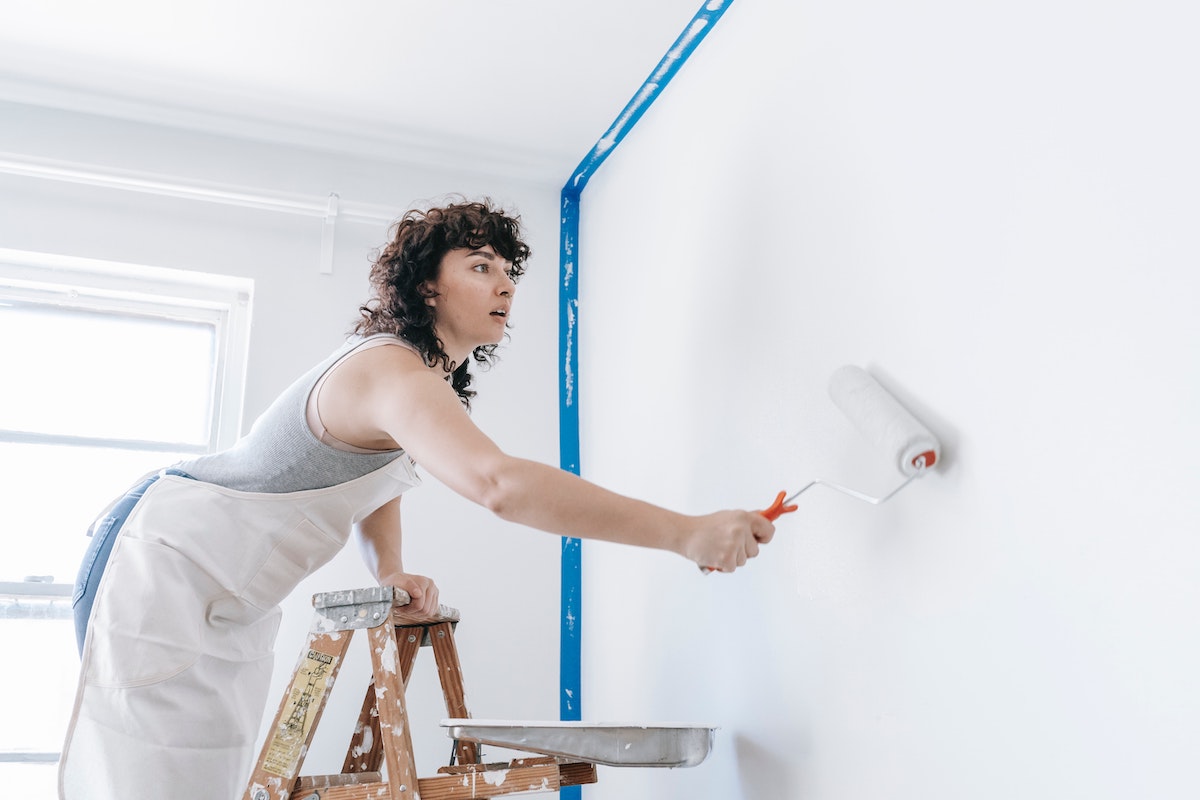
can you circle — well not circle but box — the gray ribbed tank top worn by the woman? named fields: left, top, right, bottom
left=174, top=333, right=412, bottom=494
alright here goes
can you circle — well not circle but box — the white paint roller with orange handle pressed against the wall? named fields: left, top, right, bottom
left=701, top=365, right=941, bottom=572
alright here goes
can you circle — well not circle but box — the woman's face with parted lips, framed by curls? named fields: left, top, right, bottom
left=426, top=245, right=516, bottom=363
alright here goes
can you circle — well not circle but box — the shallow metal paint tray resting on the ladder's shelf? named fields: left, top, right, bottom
left=442, top=720, right=716, bottom=766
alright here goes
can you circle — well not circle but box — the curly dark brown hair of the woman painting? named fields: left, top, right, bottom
left=354, top=198, right=532, bottom=408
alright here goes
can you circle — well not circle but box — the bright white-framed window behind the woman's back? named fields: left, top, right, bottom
left=0, top=249, right=253, bottom=796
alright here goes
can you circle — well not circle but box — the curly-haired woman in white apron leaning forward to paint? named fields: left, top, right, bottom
left=60, top=201, right=774, bottom=800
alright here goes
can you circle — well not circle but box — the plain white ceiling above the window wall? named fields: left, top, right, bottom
left=0, top=0, right=702, bottom=180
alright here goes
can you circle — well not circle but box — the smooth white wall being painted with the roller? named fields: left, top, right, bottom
left=580, top=0, right=1200, bottom=800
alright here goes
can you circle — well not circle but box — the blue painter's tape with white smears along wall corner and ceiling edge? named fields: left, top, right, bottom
left=558, top=0, right=733, bottom=743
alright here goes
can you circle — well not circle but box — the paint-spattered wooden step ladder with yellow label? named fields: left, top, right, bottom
left=242, top=587, right=596, bottom=800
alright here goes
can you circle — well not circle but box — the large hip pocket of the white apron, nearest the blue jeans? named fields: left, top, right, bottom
left=84, top=536, right=222, bottom=687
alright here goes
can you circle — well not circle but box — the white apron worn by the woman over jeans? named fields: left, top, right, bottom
left=59, top=456, right=420, bottom=800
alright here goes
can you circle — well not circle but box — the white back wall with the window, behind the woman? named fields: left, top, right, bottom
left=0, top=104, right=559, bottom=775
